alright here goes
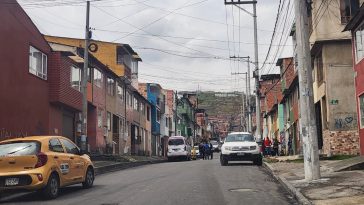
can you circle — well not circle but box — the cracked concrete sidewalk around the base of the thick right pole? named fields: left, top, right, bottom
left=264, top=157, right=364, bottom=205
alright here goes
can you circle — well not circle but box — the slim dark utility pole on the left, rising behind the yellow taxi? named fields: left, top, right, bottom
left=81, top=1, right=91, bottom=152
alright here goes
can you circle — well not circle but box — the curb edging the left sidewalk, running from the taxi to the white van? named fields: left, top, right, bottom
left=95, top=159, right=167, bottom=175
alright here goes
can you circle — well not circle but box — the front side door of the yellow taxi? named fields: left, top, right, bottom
left=60, top=138, right=85, bottom=182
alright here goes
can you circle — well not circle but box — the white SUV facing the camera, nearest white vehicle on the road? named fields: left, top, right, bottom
left=220, top=132, right=263, bottom=166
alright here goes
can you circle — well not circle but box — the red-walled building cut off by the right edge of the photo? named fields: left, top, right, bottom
left=344, top=4, right=364, bottom=155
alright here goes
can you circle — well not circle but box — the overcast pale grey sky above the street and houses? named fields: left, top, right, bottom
left=18, top=0, right=294, bottom=93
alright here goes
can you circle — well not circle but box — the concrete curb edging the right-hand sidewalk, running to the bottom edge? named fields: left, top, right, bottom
left=263, top=162, right=312, bottom=205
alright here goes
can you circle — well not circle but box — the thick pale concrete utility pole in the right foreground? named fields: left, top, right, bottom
left=294, top=0, right=320, bottom=181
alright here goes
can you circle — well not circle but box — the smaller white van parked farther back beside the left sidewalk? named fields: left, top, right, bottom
left=167, top=136, right=191, bottom=161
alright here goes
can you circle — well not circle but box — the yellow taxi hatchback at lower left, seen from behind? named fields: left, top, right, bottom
left=0, top=136, right=95, bottom=199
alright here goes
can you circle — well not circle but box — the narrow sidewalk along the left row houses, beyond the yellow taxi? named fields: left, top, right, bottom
left=91, top=155, right=167, bottom=175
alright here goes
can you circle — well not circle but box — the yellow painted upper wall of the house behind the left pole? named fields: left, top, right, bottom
left=44, top=36, right=125, bottom=76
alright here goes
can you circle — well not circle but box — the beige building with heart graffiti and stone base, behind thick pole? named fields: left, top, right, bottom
left=310, top=0, right=359, bottom=155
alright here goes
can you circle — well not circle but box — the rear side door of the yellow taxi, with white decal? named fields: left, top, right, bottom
left=48, top=138, right=72, bottom=184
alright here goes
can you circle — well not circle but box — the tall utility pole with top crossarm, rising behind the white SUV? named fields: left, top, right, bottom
left=225, top=0, right=262, bottom=140
